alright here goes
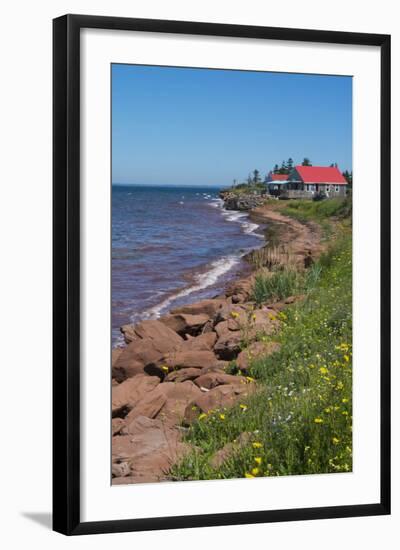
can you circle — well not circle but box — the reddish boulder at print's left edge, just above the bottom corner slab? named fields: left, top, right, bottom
left=112, top=374, right=160, bottom=418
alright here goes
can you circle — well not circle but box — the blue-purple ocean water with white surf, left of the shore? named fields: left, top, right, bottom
left=112, top=185, right=263, bottom=345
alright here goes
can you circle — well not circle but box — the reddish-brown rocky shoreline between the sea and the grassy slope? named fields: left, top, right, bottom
left=111, top=201, right=322, bottom=485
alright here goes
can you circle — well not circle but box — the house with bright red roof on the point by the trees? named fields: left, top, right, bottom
left=270, top=165, right=347, bottom=199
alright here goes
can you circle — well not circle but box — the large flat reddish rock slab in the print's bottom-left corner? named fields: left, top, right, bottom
left=112, top=416, right=189, bottom=484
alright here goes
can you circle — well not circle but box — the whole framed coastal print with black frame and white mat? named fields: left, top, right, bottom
left=53, top=15, right=390, bottom=535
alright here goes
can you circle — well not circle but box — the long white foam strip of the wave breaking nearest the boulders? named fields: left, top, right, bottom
left=131, top=256, right=240, bottom=322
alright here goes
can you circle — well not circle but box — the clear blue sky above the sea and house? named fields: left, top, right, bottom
left=112, top=65, right=352, bottom=186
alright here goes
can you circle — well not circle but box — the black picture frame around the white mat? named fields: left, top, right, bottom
left=53, top=15, right=390, bottom=535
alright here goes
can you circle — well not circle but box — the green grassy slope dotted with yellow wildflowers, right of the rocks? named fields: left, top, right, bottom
left=171, top=201, right=352, bottom=479
